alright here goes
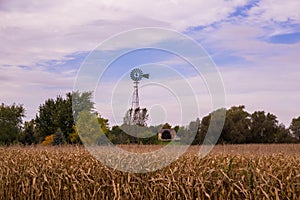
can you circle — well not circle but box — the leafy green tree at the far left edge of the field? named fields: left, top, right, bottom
left=0, top=103, right=25, bottom=144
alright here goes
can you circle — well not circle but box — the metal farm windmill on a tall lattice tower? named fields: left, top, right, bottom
left=129, top=68, right=149, bottom=125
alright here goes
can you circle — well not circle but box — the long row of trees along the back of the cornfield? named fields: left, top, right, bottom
left=0, top=91, right=300, bottom=145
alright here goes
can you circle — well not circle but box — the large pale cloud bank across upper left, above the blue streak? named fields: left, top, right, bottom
left=0, top=0, right=246, bottom=65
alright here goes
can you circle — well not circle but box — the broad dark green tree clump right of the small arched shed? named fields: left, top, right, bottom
left=193, top=105, right=296, bottom=144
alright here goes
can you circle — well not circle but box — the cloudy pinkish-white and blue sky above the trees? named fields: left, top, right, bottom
left=0, top=0, right=300, bottom=126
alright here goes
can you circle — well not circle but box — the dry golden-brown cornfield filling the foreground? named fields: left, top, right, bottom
left=0, top=144, right=300, bottom=199
